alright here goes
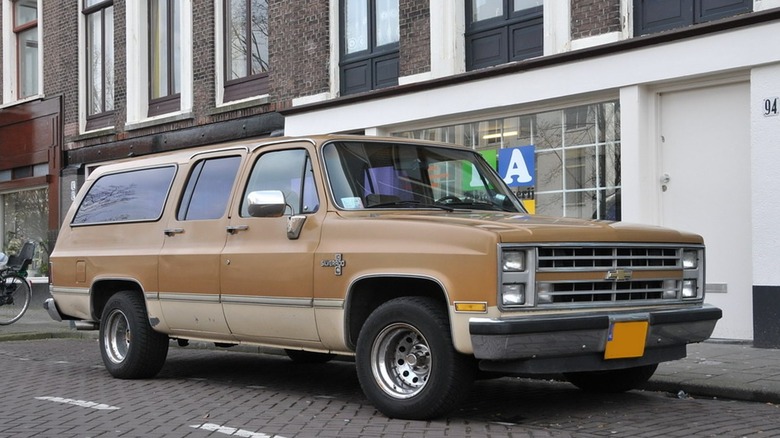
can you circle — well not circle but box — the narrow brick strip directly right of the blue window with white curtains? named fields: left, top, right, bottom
left=399, top=0, right=431, bottom=77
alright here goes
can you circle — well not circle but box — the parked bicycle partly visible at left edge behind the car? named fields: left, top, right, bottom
left=0, top=242, right=35, bottom=325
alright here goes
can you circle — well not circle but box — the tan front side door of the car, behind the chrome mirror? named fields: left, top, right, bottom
left=221, top=145, right=325, bottom=346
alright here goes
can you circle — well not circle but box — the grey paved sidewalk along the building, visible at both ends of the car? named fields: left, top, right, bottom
left=0, top=306, right=780, bottom=404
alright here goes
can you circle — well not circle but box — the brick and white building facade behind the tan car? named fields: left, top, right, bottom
left=0, top=0, right=780, bottom=347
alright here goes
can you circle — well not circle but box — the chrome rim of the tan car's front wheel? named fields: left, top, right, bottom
left=371, top=323, right=433, bottom=399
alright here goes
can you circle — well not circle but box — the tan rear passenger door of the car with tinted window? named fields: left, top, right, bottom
left=158, top=149, right=246, bottom=339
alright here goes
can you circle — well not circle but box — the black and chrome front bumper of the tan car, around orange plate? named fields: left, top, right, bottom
left=469, top=304, right=723, bottom=374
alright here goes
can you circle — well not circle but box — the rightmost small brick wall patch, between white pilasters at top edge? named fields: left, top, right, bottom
left=571, top=0, right=621, bottom=40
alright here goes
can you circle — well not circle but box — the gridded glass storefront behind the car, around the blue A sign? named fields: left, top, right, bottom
left=394, top=101, right=621, bottom=220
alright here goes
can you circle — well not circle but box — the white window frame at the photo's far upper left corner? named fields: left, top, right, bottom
left=0, top=0, right=43, bottom=107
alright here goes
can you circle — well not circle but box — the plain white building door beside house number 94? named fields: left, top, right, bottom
left=659, top=83, right=753, bottom=339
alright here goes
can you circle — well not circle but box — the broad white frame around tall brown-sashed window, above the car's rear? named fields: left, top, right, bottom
left=125, top=0, right=193, bottom=130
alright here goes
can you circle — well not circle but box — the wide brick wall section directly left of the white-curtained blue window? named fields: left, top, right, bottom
left=268, top=0, right=330, bottom=106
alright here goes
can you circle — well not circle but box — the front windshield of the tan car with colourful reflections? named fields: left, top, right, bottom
left=323, top=141, right=524, bottom=213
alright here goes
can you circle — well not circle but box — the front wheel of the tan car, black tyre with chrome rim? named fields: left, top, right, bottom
left=355, top=297, right=474, bottom=420
